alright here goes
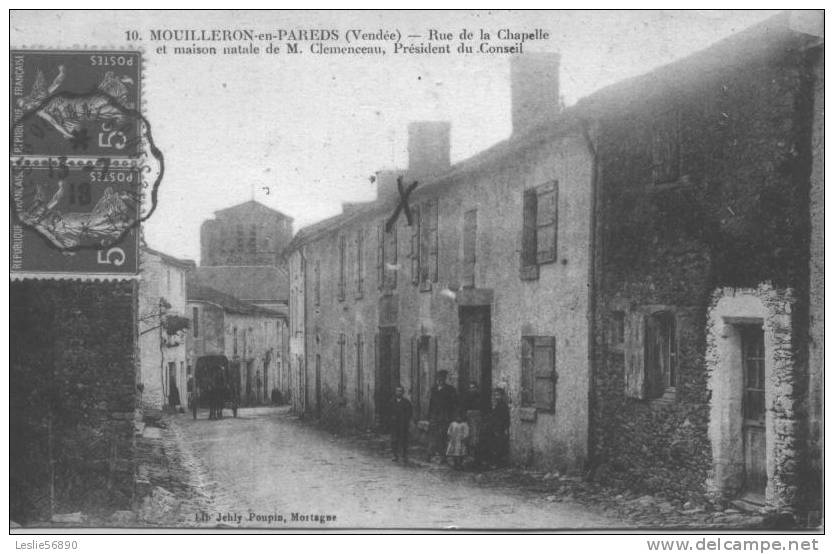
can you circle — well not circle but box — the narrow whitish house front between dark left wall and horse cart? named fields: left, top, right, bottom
left=138, top=246, right=195, bottom=409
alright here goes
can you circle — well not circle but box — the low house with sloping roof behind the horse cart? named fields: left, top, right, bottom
left=186, top=281, right=289, bottom=406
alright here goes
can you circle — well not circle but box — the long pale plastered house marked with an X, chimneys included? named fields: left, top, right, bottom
left=288, top=51, right=593, bottom=470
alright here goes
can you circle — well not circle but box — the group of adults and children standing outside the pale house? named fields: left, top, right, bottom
left=391, top=370, right=510, bottom=469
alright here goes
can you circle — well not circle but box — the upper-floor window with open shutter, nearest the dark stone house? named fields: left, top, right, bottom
left=521, top=181, right=559, bottom=280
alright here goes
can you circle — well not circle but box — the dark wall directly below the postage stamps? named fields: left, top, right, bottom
left=9, top=281, right=137, bottom=524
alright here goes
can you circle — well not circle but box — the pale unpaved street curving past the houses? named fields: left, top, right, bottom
left=161, top=408, right=623, bottom=529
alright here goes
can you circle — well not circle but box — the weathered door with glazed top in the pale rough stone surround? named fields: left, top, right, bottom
left=740, top=325, right=767, bottom=495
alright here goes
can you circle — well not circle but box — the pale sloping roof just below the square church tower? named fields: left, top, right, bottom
left=191, top=265, right=290, bottom=302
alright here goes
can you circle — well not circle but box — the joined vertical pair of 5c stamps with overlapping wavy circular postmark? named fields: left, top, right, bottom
left=9, top=50, right=163, bottom=277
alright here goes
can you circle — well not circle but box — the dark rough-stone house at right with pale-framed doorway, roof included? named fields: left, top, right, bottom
left=575, top=14, right=822, bottom=508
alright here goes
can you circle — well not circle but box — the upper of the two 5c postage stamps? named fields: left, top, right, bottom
left=9, top=50, right=142, bottom=157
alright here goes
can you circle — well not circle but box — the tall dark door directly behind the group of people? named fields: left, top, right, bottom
left=458, top=306, right=492, bottom=411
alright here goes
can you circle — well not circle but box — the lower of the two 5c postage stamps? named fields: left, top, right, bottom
left=9, top=164, right=141, bottom=274
